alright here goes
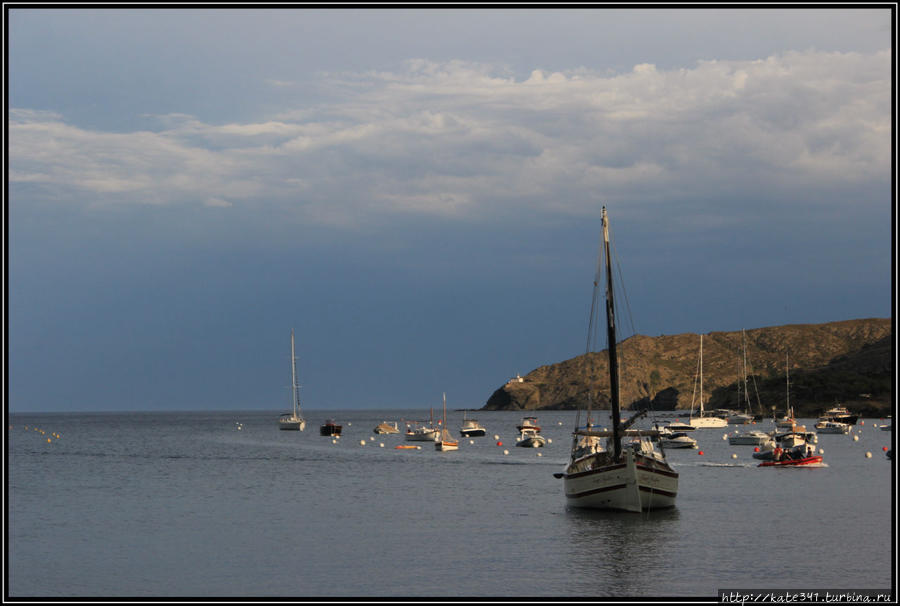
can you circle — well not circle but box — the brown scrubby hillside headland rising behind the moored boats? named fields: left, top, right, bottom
left=483, top=318, right=894, bottom=416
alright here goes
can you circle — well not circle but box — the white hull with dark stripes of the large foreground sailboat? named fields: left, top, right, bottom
left=563, top=449, right=678, bottom=512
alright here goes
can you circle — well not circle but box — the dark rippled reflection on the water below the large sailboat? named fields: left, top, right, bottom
left=566, top=507, right=680, bottom=597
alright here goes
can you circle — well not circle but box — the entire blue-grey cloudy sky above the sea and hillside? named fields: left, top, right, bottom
left=5, top=4, right=895, bottom=413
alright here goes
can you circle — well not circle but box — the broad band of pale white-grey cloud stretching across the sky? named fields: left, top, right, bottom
left=9, top=51, right=891, bottom=225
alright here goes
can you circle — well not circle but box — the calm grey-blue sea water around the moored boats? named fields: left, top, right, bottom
left=7, top=410, right=894, bottom=599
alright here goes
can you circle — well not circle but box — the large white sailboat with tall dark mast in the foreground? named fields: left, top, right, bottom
left=553, top=207, right=678, bottom=512
